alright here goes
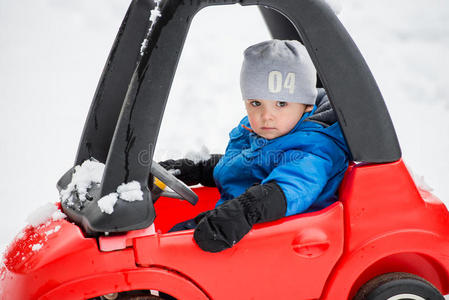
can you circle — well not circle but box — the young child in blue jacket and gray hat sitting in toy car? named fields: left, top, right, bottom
left=161, top=40, right=348, bottom=252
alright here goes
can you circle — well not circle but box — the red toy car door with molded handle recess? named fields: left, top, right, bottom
left=135, top=199, right=343, bottom=299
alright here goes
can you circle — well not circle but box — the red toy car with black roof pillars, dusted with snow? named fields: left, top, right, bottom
left=0, top=0, right=449, bottom=300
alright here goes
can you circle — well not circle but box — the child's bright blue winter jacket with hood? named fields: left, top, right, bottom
left=214, top=91, right=349, bottom=216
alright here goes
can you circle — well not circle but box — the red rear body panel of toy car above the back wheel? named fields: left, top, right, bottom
left=323, top=160, right=449, bottom=299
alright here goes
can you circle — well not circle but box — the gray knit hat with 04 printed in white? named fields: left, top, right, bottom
left=240, top=40, right=317, bottom=105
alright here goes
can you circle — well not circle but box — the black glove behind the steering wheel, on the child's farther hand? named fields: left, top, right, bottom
left=159, top=154, right=223, bottom=187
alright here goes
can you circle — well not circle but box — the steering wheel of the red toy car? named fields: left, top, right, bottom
left=151, top=160, right=198, bottom=205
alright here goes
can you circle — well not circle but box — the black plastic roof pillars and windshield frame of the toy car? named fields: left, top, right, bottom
left=58, top=0, right=401, bottom=234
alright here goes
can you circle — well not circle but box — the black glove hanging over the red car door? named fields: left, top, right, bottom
left=193, top=181, right=287, bottom=252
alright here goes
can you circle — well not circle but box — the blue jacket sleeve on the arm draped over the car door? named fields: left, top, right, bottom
left=262, top=138, right=347, bottom=216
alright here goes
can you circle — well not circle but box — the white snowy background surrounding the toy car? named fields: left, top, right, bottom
left=0, top=0, right=449, bottom=290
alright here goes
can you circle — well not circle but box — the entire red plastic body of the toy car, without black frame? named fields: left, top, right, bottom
left=0, top=160, right=449, bottom=300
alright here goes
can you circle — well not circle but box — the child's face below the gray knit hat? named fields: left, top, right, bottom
left=245, top=99, right=313, bottom=140
